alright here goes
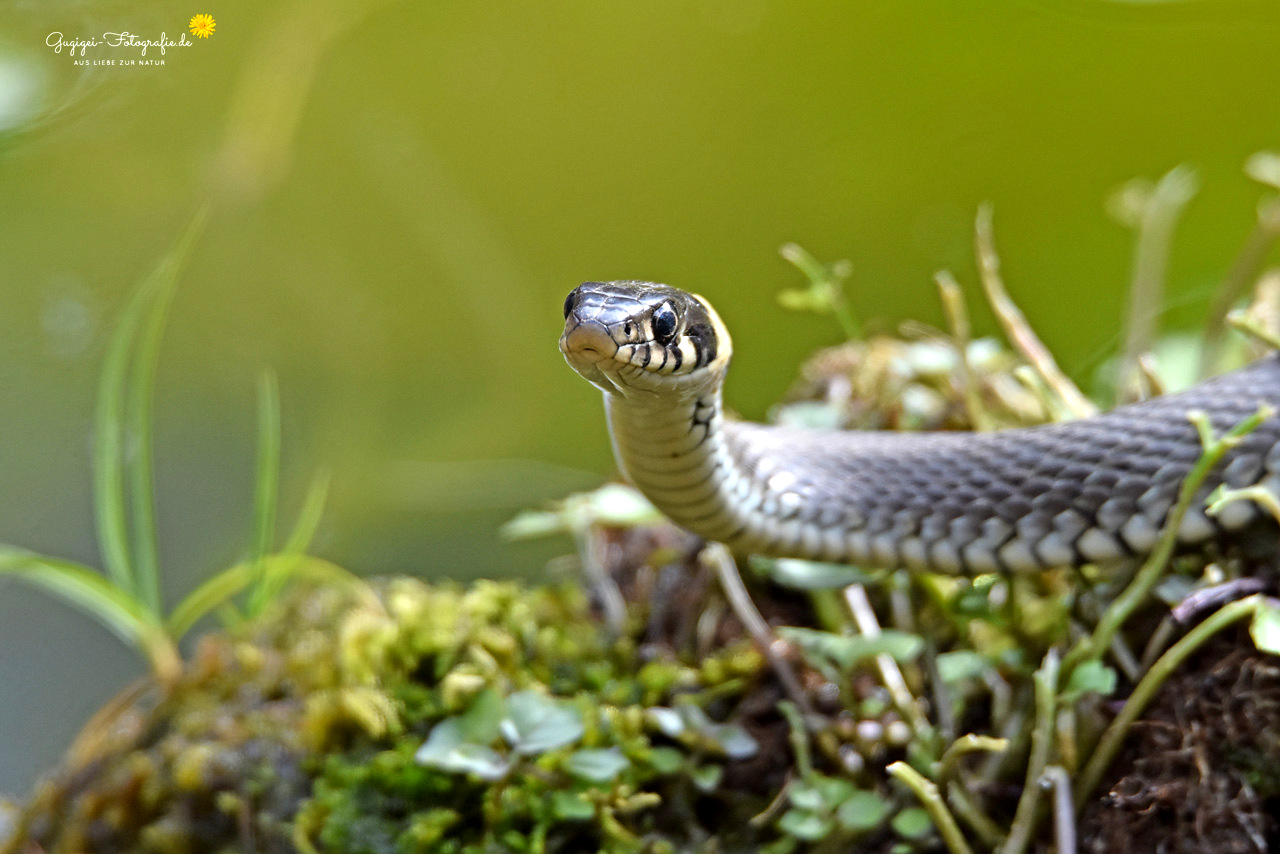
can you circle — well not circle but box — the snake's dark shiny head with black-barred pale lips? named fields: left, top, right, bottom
left=559, top=282, right=732, bottom=396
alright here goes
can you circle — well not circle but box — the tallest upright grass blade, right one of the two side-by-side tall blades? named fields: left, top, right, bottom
left=124, top=211, right=205, bottom=615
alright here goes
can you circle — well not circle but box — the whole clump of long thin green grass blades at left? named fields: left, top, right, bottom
left=0, top=214, right=344, bottom=684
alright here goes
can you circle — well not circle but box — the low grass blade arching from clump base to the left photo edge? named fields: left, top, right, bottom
left=0, top=547, right=182, bottom=681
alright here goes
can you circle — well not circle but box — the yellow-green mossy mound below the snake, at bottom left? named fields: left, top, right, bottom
left=0, top=579, right=783, bottom=854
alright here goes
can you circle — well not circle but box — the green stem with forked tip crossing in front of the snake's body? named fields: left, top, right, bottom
left=1062, top=406, right=1274, bottom=677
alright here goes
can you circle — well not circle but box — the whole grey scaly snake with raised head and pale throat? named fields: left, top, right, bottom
left=561, top=282, right=1280, bottom=574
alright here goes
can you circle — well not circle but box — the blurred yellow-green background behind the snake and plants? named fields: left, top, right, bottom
left=0, top=0, right=1280, bottom=795
